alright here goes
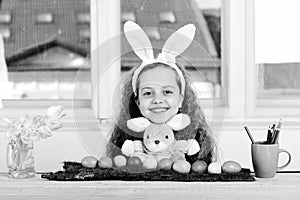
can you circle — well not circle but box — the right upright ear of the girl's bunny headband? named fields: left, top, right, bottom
left=161, top=24, right=196, bottom=60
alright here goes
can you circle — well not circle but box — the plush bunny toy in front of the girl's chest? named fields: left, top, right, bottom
left=121, top=114, right=200, bottom=168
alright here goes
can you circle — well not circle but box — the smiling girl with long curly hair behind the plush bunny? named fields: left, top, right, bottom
left=107, top=63, right=215, bottom=164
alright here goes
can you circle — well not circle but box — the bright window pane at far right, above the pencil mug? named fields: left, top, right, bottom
left=254, top=0, right=300, bottom=99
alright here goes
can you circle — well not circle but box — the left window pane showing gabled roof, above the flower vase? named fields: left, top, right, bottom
left=0, top=0, right=91, bottom=100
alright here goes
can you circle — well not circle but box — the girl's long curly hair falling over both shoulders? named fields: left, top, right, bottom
left=106, top=63, right=215, bottom=164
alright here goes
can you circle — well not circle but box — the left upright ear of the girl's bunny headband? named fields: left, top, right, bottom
left=124, top=21, right=154, bottom=61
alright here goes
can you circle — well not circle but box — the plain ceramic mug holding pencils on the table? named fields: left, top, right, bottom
left=251, top=142, right=292, bottom=178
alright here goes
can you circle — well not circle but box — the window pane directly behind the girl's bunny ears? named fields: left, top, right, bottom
left=121, top=0, right=222, bottom=99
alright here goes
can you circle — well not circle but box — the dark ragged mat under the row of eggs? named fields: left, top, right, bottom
left=41, top=162, right=255, bottom=182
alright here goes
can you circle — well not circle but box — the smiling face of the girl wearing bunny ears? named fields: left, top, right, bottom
left=137, top=67, right=183, bottom=124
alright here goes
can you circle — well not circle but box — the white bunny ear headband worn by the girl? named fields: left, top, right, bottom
left=124, top=21, right=196, bottom=95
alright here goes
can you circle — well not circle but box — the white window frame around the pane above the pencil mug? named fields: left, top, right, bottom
left=204, top=0, right=300, bottom=122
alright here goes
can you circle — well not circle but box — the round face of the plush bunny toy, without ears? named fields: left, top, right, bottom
left=143, top=124, right=175, bottom=153
